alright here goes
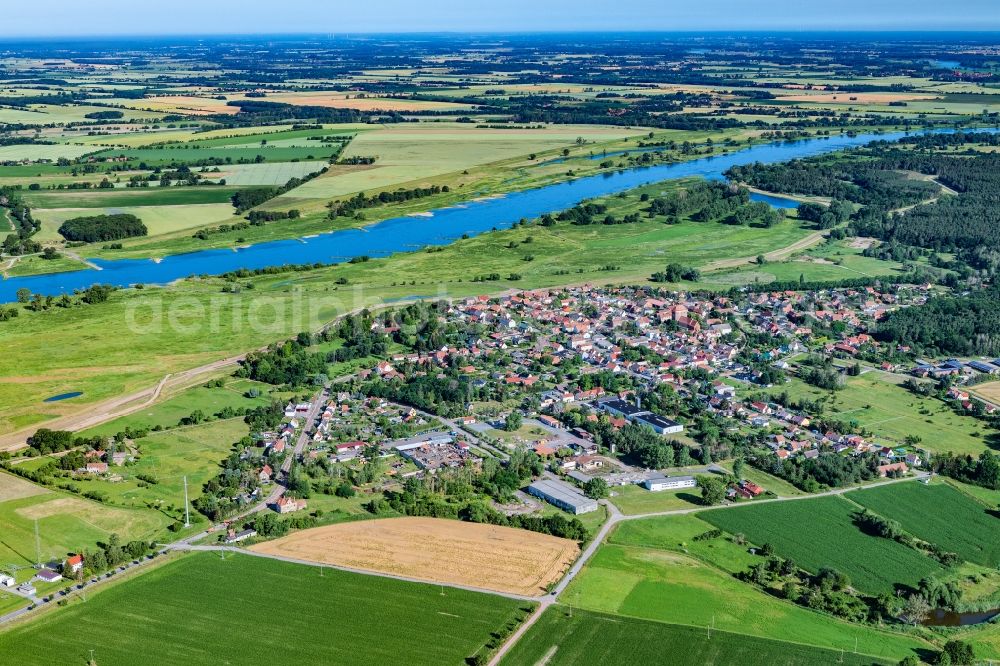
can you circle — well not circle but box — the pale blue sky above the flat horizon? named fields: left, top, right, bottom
left=0, top=0, right=1000, bottom=39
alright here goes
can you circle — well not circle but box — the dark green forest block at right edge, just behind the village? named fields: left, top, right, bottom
left=874, top=286, right=1000, bottom=356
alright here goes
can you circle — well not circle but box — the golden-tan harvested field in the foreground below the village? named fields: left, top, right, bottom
left=250, top=518, right=580, bottom=596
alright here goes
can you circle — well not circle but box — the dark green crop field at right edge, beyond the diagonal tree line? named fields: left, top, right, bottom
left=846, top=482, right=1000, bottom=567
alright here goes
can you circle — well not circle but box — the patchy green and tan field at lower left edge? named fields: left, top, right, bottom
left=0, top=472, right=170, bottom=566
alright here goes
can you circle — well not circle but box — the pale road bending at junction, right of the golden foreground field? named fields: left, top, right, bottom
left=490, top=473, right=930, bottom=666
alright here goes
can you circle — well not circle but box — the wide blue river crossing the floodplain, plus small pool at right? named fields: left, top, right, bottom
left=0, top=130, right=990, bottom=302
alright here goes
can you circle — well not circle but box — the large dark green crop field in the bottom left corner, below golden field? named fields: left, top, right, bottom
left=0, top=553, right=526, bottom=666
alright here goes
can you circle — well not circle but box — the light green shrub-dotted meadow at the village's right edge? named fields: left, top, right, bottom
left=772, top=370, right=995, bottom=456
